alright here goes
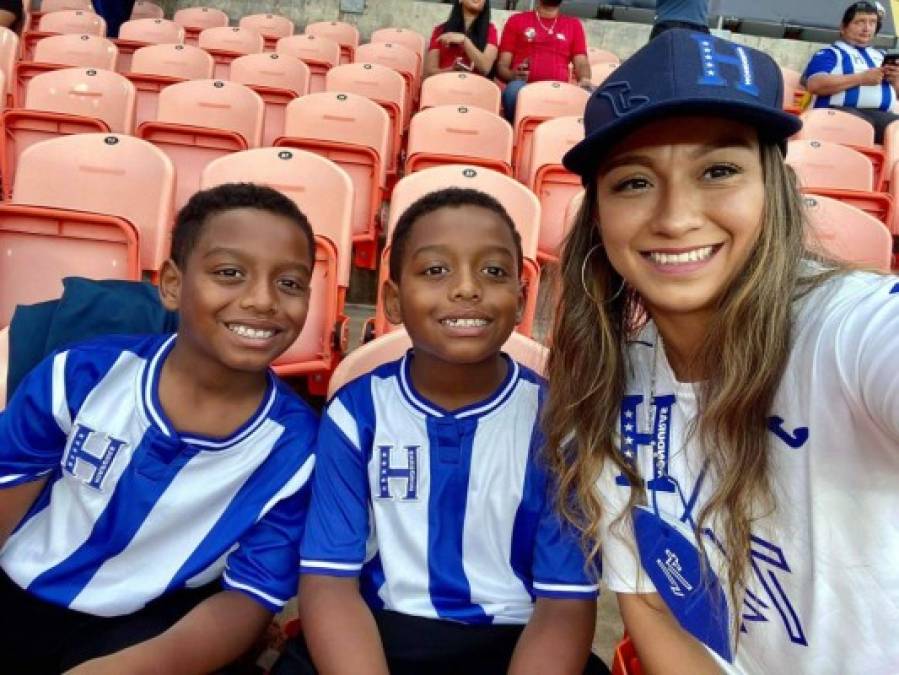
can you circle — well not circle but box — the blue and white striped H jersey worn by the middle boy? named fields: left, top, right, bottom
left=301, top=352, right=598, bottom=624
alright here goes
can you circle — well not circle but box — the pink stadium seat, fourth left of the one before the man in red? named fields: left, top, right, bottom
left=125, top=45, right=215, bottom=128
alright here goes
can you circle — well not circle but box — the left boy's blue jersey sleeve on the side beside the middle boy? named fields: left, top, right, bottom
left=222, top=454, right=315, bottom=612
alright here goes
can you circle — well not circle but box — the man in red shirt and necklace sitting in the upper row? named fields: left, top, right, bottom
left=496, top=0, right=592, bottom=121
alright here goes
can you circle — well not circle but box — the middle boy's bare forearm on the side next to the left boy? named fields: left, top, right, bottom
left=299, top=574, right=388, bottom=675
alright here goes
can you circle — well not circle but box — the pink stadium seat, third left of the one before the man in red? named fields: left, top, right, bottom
left=231, top=52, right=311, bottom=146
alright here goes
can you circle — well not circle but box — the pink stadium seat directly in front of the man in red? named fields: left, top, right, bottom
left=512, top=82, right=590, bottom=182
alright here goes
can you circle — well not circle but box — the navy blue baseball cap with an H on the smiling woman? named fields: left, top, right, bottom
left=562, top=29, right=802, bottom=182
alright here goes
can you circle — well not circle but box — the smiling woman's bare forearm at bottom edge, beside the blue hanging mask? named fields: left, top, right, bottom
left=618, top=593, right=723, bottom=675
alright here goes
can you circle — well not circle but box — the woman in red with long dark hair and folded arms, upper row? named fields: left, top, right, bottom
left=424, top=0, right=499, bottom=77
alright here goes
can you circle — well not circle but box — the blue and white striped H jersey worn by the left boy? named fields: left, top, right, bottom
left=0, top=335, right=318, bottom=616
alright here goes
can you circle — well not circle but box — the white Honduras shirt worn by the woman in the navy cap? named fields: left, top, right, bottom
left=598, top=272, right=899, bottom=675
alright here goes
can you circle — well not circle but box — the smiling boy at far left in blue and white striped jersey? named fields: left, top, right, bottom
left=0, top=184, right=318, bottom=675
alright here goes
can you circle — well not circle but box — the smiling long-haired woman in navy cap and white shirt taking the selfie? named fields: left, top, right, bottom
left=545, top=29, right=899, bottom=675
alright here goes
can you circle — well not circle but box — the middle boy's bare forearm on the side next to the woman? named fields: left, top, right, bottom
left=509, top=597, right=596, bottom=675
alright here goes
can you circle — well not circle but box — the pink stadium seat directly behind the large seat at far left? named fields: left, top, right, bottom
left=0, top=68, right=135, bottom=198
